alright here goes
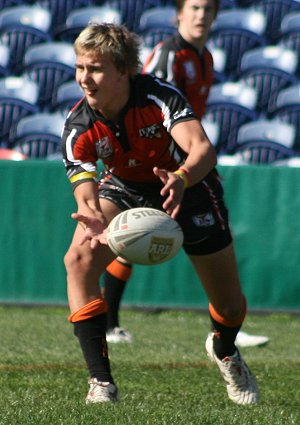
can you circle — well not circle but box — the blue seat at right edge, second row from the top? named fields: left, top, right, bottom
left=240, top=46, right=298, bottom=116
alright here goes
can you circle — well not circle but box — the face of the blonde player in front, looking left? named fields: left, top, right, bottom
left=76, top=52, right=129, bottom=118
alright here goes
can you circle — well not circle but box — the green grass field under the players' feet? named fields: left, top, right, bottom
left=0, top=306, right=300, bottom=425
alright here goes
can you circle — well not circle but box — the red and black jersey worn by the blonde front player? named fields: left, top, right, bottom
left=62, top=74, right=197, bottom=188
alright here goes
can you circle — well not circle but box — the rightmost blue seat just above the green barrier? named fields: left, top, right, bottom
left=234, top=120, right=296, bottom=164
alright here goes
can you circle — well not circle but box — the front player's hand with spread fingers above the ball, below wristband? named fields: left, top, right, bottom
left=153, top=167, right=184, bottom=218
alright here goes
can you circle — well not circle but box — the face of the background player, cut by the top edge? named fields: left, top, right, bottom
left=178, top=0, right=216, bottom=46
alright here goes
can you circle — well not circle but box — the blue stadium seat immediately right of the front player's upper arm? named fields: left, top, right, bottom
left=204, top=82, right=257, bottom=154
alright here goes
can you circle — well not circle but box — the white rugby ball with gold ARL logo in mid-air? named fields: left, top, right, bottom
left=107, top=207, right=183, bottom=265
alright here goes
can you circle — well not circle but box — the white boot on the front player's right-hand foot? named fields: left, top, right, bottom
left=205, top=333, right=259, bottom=404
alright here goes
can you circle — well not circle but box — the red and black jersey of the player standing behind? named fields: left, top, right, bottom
left=143, top=33, right=214, bottom=118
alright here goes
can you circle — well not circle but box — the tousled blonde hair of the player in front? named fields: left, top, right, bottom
left=74, top=23, right=141, bottom=76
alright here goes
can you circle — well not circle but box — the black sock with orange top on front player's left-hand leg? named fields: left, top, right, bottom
left=69, top=300, right=113, bottom=383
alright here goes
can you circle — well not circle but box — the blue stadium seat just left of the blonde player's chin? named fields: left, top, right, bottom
left=52, top=81, right=83, bottom=117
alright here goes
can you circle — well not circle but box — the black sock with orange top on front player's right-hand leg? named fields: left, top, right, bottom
left=209, top=300, right=246, bottom=360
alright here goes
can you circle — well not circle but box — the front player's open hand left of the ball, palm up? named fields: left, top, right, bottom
left=71, top=213, right=107, bottom=249
